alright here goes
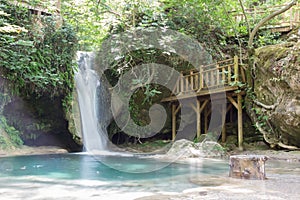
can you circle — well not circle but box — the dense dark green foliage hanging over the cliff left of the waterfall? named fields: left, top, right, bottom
left=0, top=0, right=76, bottom=97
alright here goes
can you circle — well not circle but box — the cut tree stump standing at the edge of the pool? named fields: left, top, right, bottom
left=229, top=155, right=268, bottom=180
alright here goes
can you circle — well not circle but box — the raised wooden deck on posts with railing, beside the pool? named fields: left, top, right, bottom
left=162, top=56, right=246, bottom=147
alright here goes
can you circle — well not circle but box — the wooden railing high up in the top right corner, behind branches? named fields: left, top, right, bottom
left=231, top=3, right=300, bottom=31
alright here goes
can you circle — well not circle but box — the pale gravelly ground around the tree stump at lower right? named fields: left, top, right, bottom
left=136, top=150, right=300, bottom=200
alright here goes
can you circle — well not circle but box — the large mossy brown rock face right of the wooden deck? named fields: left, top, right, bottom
left=254, top=28, right=300, bottom=147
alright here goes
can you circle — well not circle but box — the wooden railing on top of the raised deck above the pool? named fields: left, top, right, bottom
left=173, top=56, right=246, bottom=95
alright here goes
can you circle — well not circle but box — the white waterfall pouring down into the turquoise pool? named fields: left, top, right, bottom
left=75, top=52, right=109, bottom=152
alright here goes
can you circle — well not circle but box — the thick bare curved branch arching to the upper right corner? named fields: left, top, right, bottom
left=248, top=0, right=296, bottom=48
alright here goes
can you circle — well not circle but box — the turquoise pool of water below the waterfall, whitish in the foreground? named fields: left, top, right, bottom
left=0, top=154, right=228, bottom=200
